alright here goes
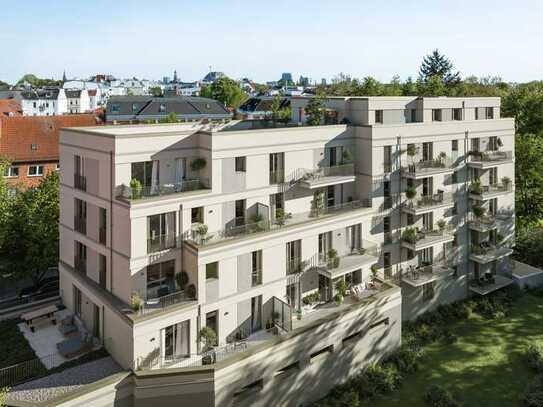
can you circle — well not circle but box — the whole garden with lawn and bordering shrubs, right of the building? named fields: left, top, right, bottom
left=315, top=289, right=543, bottom=407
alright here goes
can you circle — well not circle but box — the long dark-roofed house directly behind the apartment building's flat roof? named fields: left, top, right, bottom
left=106, top=96, right=232, bottom=123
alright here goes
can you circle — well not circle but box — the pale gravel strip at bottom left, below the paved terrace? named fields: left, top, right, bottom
left=8, top=357, right=123, bottom=401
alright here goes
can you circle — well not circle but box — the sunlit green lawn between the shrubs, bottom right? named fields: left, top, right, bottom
left=365, top=294, right=543, bottom=407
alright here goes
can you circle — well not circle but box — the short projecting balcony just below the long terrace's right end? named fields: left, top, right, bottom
left=317, top=242, right=379, bottom=279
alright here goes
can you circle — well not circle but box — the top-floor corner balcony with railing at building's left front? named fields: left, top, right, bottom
left=116, top=178, right=211, bottom=201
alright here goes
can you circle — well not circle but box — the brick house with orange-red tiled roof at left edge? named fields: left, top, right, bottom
left=0, top=113, right=98, bottom=189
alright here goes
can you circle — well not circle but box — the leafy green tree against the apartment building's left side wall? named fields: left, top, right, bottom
left=2, top=171, right=59, bottom=284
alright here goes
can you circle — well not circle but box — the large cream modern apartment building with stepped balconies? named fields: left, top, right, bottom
left=59, top=97, right=514, bottom=406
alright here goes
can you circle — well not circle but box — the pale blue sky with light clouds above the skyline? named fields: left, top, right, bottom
left=0, top=0, right=543, bottom=83
